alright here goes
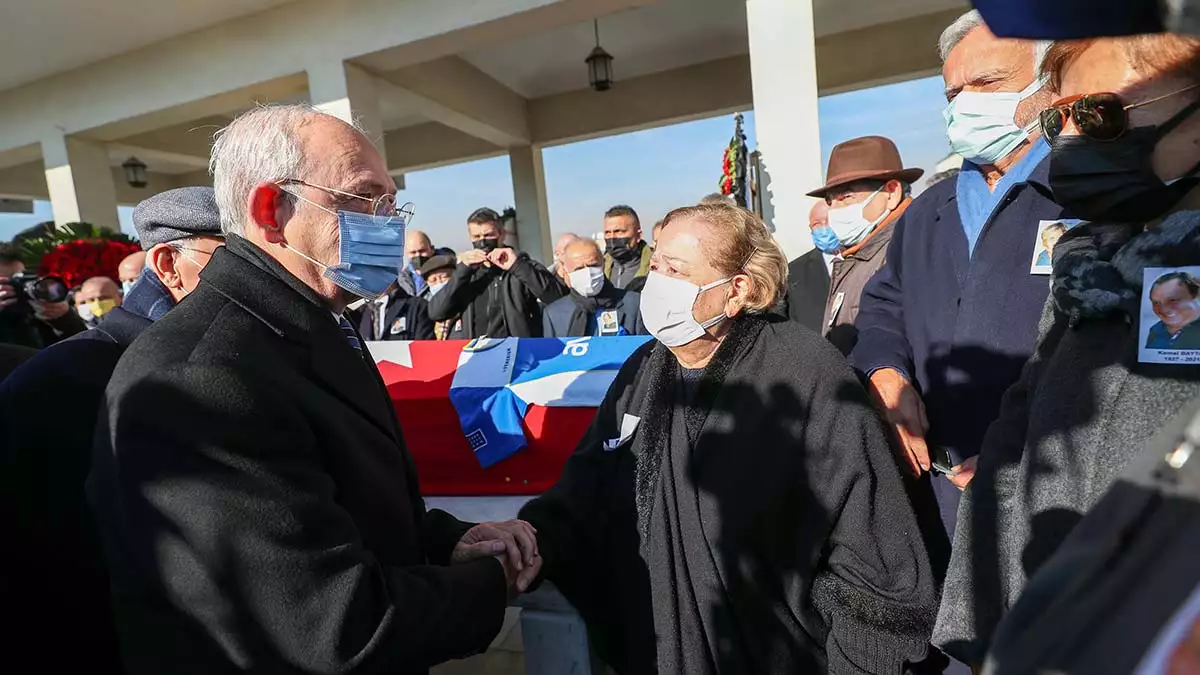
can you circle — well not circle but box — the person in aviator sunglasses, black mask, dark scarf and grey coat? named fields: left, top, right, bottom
left=934, top=34, right=1200, bottom=664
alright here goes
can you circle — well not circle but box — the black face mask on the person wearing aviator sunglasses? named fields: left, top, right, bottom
left=1050, top=101, right=1200, bottom=223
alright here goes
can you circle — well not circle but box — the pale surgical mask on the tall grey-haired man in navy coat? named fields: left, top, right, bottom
left=942, top=73, right=1046, bottom=165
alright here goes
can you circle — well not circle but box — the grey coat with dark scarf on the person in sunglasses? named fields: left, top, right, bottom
left=932, top=211, right=1200, bottom=663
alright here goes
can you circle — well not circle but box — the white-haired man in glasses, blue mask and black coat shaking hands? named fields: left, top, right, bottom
left=89, top=106, right=538, bottom=674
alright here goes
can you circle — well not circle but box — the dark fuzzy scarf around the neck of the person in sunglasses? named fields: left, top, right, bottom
left=1050, top=211, right=1200, bottom=325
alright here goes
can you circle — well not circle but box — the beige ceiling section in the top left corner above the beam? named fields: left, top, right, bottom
left=0, top=0, right=297, bottom=89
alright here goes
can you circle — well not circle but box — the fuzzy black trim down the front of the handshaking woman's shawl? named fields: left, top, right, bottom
left=634, top=316, right=767, bottom=539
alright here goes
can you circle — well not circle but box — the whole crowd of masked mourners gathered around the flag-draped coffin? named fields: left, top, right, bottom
left=0, top=6, right=1200, bottom=675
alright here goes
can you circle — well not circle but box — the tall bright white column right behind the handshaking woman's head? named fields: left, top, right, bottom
left=746, top=0, right=823, bottom=258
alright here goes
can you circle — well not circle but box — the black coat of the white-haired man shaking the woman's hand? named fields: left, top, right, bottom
left=89, top=235, right=506, bottom=674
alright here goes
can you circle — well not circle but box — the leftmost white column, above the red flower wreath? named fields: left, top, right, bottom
left=42, top=133, right=121, bottom=231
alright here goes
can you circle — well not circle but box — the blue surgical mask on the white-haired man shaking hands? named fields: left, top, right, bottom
left=292, top=205, right=404, bottom=300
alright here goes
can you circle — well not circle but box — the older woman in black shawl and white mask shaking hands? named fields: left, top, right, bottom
left=521, top=204, right=941, bottom=675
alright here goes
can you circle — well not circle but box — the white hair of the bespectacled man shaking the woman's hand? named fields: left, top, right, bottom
left=209, top=103, right=361, bottom=234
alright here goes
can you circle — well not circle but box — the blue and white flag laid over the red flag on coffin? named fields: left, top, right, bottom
left=450, top=336, right=650, bottom=467
